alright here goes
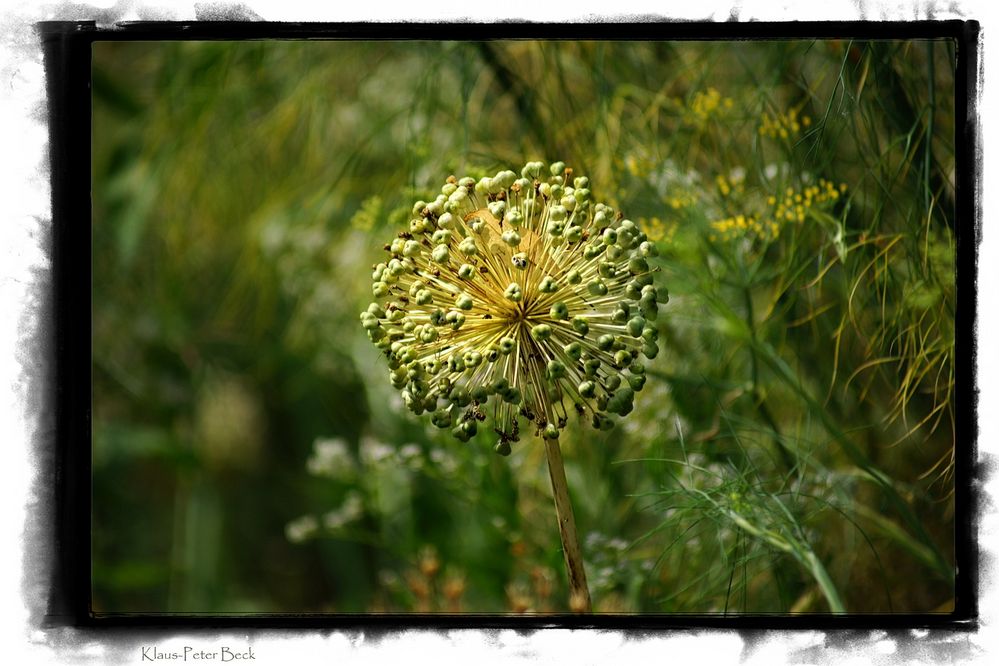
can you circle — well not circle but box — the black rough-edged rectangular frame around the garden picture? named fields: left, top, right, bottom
left=41, top=17, right=983, bottom=633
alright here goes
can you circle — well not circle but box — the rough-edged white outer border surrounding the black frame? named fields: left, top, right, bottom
left=0, top=0, right=999, bottom=666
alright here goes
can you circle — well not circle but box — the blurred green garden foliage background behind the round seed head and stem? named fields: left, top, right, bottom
left=93, top=41, right=960, bottom=613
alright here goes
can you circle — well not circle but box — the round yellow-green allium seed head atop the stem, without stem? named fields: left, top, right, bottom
left=361, top=162, right=667, bottom=455
